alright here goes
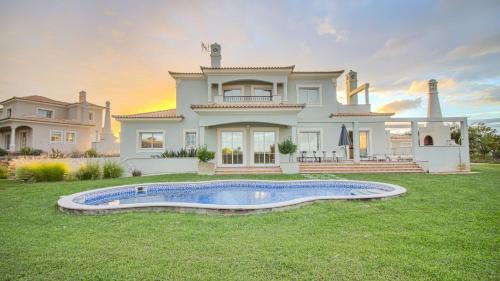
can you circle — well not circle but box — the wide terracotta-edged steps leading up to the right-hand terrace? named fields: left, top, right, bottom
left=300, top=162, right=424, bottom=174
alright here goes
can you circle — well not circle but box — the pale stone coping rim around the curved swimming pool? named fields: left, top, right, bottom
left=57, top=179, right=406, bottom=214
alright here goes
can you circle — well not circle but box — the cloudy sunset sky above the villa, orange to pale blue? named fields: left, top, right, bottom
left=0, top=0, right=500, bottom=131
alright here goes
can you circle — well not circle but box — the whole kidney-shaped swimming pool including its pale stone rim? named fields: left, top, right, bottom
left=58, top=180, right=406, bottom=214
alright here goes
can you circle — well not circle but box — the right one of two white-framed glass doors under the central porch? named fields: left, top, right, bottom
left=253, top=132, right=276, bottom=165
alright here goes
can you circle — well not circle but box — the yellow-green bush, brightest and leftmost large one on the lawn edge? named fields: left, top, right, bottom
left=16, top=163, right=68, bottom=182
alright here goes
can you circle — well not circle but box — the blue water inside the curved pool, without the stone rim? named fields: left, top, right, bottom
left=78, top=180, right=394, bottom=206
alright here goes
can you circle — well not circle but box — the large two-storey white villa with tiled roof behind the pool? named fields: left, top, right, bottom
left=114, top=43, right=469, bottom=172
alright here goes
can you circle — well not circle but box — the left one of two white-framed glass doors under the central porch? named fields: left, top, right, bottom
left=221, top=131, right=243, bottom=166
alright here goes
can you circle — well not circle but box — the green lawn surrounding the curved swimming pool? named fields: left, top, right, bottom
left=0, top=164, right=500, bottom=280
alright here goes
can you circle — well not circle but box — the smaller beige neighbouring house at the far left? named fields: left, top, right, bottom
left=0, top=91, right=119, bottom=153
